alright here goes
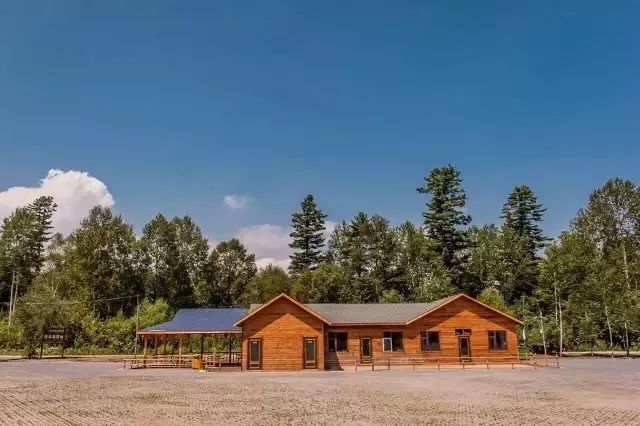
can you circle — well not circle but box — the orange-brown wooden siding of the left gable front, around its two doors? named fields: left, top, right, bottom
left=242, top=298, right=324, bottom=370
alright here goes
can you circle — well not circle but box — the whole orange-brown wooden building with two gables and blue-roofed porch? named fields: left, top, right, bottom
left=138, top=294, right=522, bottom=370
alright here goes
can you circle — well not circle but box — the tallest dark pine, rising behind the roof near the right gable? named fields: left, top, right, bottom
left=417, top=165, right=471, bottom=269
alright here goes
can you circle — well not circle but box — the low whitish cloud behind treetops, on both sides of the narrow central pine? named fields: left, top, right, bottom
left=236, top=221, right=336, bottom=269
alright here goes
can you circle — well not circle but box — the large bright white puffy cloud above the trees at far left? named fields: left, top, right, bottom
left=0, top=169, right=114, bottom=234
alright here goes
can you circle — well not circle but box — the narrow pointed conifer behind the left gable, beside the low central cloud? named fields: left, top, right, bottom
left=289, top=194, right=327, bottom=274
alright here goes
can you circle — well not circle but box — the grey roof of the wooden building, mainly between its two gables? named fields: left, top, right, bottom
left=249, top=297, right=449, bottom=325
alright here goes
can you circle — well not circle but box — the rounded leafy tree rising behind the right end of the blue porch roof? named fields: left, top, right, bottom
left=201, top=238, right=257, bottom=307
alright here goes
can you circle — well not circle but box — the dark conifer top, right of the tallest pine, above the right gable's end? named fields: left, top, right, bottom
left=500, top=185, right=548, bottom=259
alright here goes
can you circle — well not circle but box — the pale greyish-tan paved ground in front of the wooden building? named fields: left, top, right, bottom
left=0, top=359, right=640, bottom=425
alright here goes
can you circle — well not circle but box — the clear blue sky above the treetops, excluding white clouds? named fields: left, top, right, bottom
left=0, top=0, right=640, bottom=262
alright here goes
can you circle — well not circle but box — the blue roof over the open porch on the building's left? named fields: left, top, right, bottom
left=138, top=308, right=247, bottom=334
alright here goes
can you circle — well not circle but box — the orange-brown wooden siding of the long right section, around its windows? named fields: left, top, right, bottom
left=325, top=298, right=518, bottom=362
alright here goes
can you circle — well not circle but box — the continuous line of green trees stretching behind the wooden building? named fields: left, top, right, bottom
left=0, top=165, right=640, bottom=354
